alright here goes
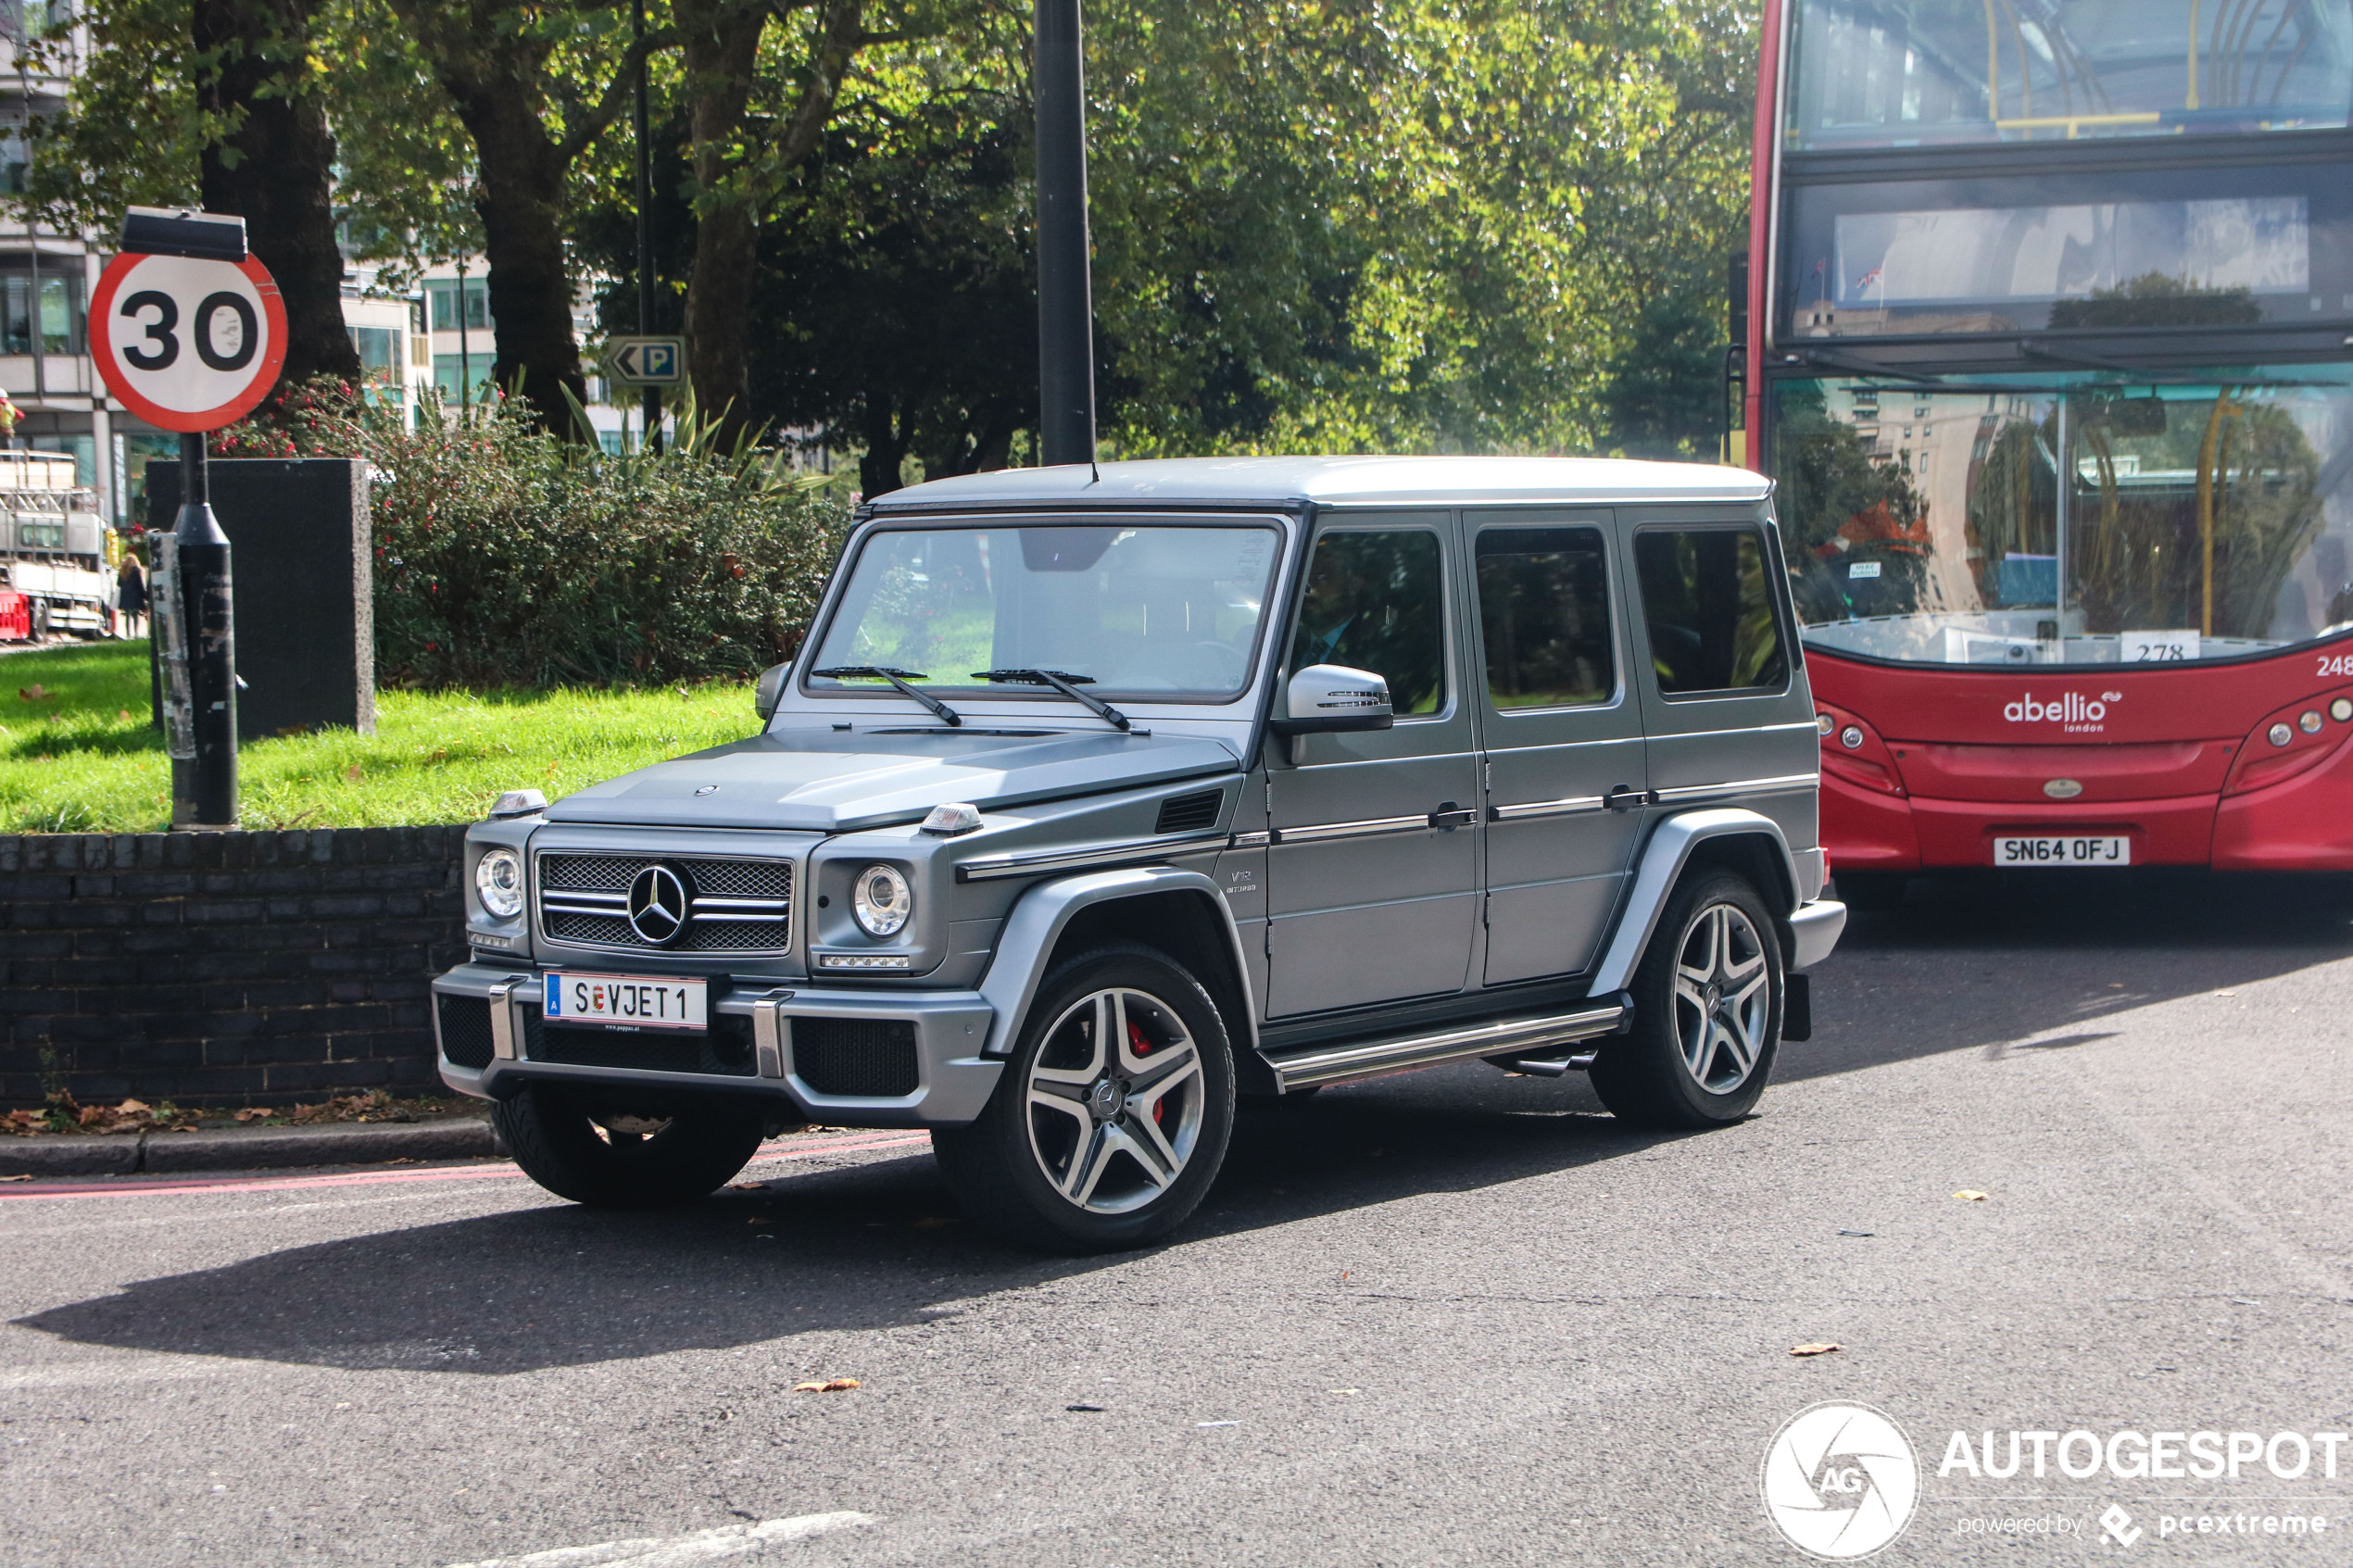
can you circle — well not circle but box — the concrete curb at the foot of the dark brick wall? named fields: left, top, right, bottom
left=0, top=1117, right=506, bottom=1175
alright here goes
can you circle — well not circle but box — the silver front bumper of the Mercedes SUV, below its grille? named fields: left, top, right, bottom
left=433, top=964, right=1005, bottom=1126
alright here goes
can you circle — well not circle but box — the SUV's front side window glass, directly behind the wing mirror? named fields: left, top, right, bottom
left=1291, top=529, right=1447, bottom=720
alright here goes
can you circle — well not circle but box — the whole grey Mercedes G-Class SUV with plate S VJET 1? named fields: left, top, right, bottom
left=433, top=458, right=1844, bottom=1250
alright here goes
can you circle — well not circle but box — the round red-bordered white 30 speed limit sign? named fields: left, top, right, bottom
left=90, top=252, right=287, bottom=433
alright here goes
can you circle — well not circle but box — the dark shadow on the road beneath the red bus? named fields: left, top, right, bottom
left=1777, top=868, right=2353, bottom=1082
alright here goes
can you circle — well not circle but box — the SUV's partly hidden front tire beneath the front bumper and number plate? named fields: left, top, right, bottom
left=492, top=1086, right=765, bottom=1209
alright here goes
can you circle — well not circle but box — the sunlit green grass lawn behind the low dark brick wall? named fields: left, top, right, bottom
left=0, top=642, right=760, bottom=833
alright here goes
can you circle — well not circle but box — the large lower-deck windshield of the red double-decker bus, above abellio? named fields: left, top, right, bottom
left=1774, top=364, right=2353, bottom=663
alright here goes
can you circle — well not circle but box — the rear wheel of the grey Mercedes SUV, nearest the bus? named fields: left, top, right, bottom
left=1591, top=872, right=1788, bottom=1128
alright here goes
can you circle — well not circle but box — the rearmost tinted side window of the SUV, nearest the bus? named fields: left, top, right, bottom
left=1633, top=529, right=1788, bottom=696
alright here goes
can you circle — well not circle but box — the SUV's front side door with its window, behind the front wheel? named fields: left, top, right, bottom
left=1266, top=512, right=1478, bottom=1018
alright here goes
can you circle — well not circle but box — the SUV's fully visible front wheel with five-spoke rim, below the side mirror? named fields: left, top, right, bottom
left=932, top=943, right=1233, bottom=1253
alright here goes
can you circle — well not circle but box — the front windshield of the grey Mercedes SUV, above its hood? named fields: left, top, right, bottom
left=807, top=524, right=1280, bottom=700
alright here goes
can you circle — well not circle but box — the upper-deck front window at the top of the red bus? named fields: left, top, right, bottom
left=1786, top=0, right=2353, bottom=150
